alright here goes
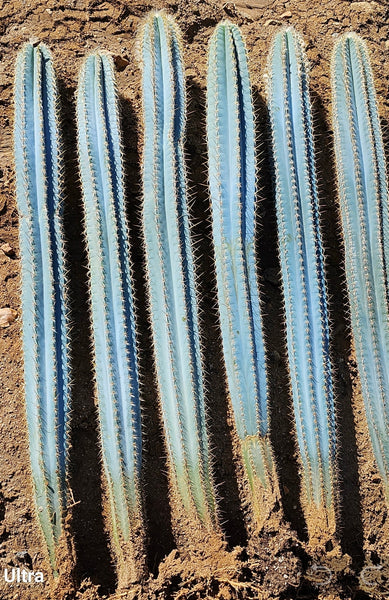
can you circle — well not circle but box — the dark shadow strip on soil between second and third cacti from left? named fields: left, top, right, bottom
left=119, top=92, right=175, bottom=574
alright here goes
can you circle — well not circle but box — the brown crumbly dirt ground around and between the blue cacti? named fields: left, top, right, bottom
left=0, top=0, right=389, bottom=600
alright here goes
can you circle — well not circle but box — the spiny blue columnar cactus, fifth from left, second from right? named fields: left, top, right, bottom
left=268, top=29, right=337, bottom=541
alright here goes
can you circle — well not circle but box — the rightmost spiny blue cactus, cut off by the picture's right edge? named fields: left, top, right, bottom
left=332, top=34, right=389, bottom=501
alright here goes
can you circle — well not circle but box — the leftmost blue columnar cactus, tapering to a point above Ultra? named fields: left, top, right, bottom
left=14, top=44, right=70, bottom=569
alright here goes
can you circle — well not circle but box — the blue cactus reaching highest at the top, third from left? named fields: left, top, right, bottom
left=140, top=13, right=216, bottom=526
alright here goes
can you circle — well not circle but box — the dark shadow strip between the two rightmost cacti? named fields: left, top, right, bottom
left=311, top=93, right=363, bottom=568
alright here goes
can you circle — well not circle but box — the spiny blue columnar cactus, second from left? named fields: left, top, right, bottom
left=77, top=53, right=141, bottom=541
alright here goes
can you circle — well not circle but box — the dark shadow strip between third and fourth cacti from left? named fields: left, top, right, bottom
left=186, top=77, right=247, bottom=547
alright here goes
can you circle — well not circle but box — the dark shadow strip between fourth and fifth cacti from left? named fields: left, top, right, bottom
left=253, top=88, right=308, bottom=541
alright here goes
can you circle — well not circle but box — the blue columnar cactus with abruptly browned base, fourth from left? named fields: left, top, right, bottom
left=207, top=22, right=276, bottom=526
